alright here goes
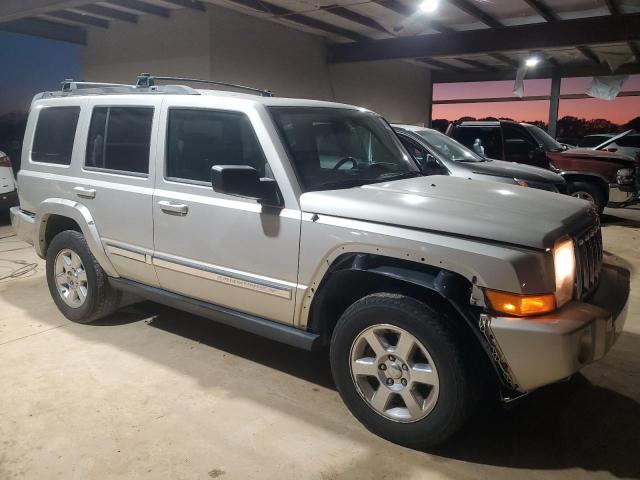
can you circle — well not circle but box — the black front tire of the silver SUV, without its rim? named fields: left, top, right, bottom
left=330, top=293, right=480, bottom=447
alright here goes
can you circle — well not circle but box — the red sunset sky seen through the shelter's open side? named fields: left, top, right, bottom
left=432, top=75, right=640, bottom=124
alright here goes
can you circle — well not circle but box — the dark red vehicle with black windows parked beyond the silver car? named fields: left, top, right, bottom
left=447, top=121, right=638, bottom=212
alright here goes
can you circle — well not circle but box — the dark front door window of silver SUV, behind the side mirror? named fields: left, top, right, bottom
left=166, top=109, right=271, bottom=182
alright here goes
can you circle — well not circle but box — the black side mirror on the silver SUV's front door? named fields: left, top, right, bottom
left=211, top=165, right=282, bottom=207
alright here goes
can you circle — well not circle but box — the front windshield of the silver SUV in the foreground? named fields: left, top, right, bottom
left=269, top=107, right=420, bottom=191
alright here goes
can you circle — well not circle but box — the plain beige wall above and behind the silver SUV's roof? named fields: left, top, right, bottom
left=81, top=6, right=431, bottom=123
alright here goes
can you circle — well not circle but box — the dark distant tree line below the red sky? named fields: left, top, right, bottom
left=431, top=116, right=640, bottom=141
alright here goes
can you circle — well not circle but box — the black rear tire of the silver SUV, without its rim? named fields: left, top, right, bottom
left=46, top=230, right=121, bottom=323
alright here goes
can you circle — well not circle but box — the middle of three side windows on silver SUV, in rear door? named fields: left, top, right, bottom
left=85, top=107, right=153, bottom=173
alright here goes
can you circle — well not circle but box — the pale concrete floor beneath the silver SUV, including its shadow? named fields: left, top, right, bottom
left=0, top=210, right=640, bottom=480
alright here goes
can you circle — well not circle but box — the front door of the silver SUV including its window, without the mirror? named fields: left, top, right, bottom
left=153, top=101, right=301, bottom=324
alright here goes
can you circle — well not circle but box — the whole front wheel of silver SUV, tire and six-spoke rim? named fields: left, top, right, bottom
left=331, top=293, right=477, bottom=446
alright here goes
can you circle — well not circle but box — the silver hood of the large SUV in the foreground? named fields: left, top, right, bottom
left=300, top=175, right=596, bottom=249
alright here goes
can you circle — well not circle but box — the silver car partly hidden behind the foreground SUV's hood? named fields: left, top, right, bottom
left=392, top=125, right=566, bottom=193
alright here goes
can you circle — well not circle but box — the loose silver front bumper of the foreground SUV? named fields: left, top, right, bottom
left=485, top=254, right=629, bottom=392
